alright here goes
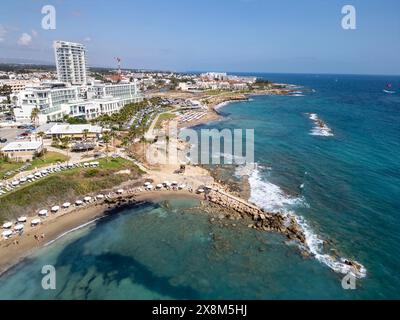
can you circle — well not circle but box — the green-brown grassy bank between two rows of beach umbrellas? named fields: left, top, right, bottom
left=0, top=158, right=141, bottom=223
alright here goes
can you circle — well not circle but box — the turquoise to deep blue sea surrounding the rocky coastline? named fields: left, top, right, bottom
left=0, top=74, right=400, bottom=299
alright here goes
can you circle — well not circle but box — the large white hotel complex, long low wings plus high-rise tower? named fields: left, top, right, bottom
left=13, top=41, right=143, bottom=124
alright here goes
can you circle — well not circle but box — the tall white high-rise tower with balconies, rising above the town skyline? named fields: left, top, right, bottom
left=54, top=41, right=87, bottom=85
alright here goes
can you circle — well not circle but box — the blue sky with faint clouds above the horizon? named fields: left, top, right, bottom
left=0, top=0, right=400, bottom=75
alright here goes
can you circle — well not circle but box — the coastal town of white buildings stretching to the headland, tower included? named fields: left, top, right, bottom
left=0, top=41, right=281, bottom=168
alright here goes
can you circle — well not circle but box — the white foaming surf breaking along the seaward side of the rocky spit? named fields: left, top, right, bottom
left=249, top=167, right=367, bottom=278
